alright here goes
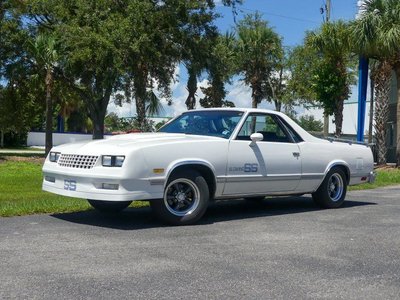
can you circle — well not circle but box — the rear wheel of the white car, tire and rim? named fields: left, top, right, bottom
left=312, top=167, right=347, bottom=208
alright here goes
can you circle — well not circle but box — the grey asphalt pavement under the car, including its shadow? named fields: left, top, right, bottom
left=0, top=186, right=400, bottom=299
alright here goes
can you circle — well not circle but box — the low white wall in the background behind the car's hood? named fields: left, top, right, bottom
left=26, top=132, right=111, bottom=146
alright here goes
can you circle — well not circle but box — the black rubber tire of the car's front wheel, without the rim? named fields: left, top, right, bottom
left=150, top=170, right=210, bottom=225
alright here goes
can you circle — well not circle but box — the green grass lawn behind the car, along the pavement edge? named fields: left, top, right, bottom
left=0, top=156, right=400, bottom=217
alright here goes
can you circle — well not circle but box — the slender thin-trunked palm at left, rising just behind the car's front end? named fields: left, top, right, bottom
left=30, top=34, right=59, bottom=155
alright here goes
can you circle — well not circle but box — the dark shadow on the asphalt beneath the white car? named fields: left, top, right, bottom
left=51, top=196, right=376, bottom=230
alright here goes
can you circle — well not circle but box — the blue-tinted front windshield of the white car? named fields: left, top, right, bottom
left=159, top=110, right=243, bottom=139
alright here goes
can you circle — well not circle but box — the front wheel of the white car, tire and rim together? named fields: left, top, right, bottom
left=150, top=170, right=210, bottom=225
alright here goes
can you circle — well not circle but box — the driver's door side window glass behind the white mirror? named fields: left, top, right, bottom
left=236, top=114, right=292, bottom=143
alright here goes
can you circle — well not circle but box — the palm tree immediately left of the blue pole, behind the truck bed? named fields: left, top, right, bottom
left=306, top=21, right=353, bottom=136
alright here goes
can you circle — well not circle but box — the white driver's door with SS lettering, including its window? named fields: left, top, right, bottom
left=223, top=113, right=301, bottom=195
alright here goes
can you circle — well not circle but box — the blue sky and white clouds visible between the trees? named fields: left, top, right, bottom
left=108, top=0, right=357, bottom=117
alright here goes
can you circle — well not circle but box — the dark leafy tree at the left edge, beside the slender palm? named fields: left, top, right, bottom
left=0, top=1, right=42, bottom=147
